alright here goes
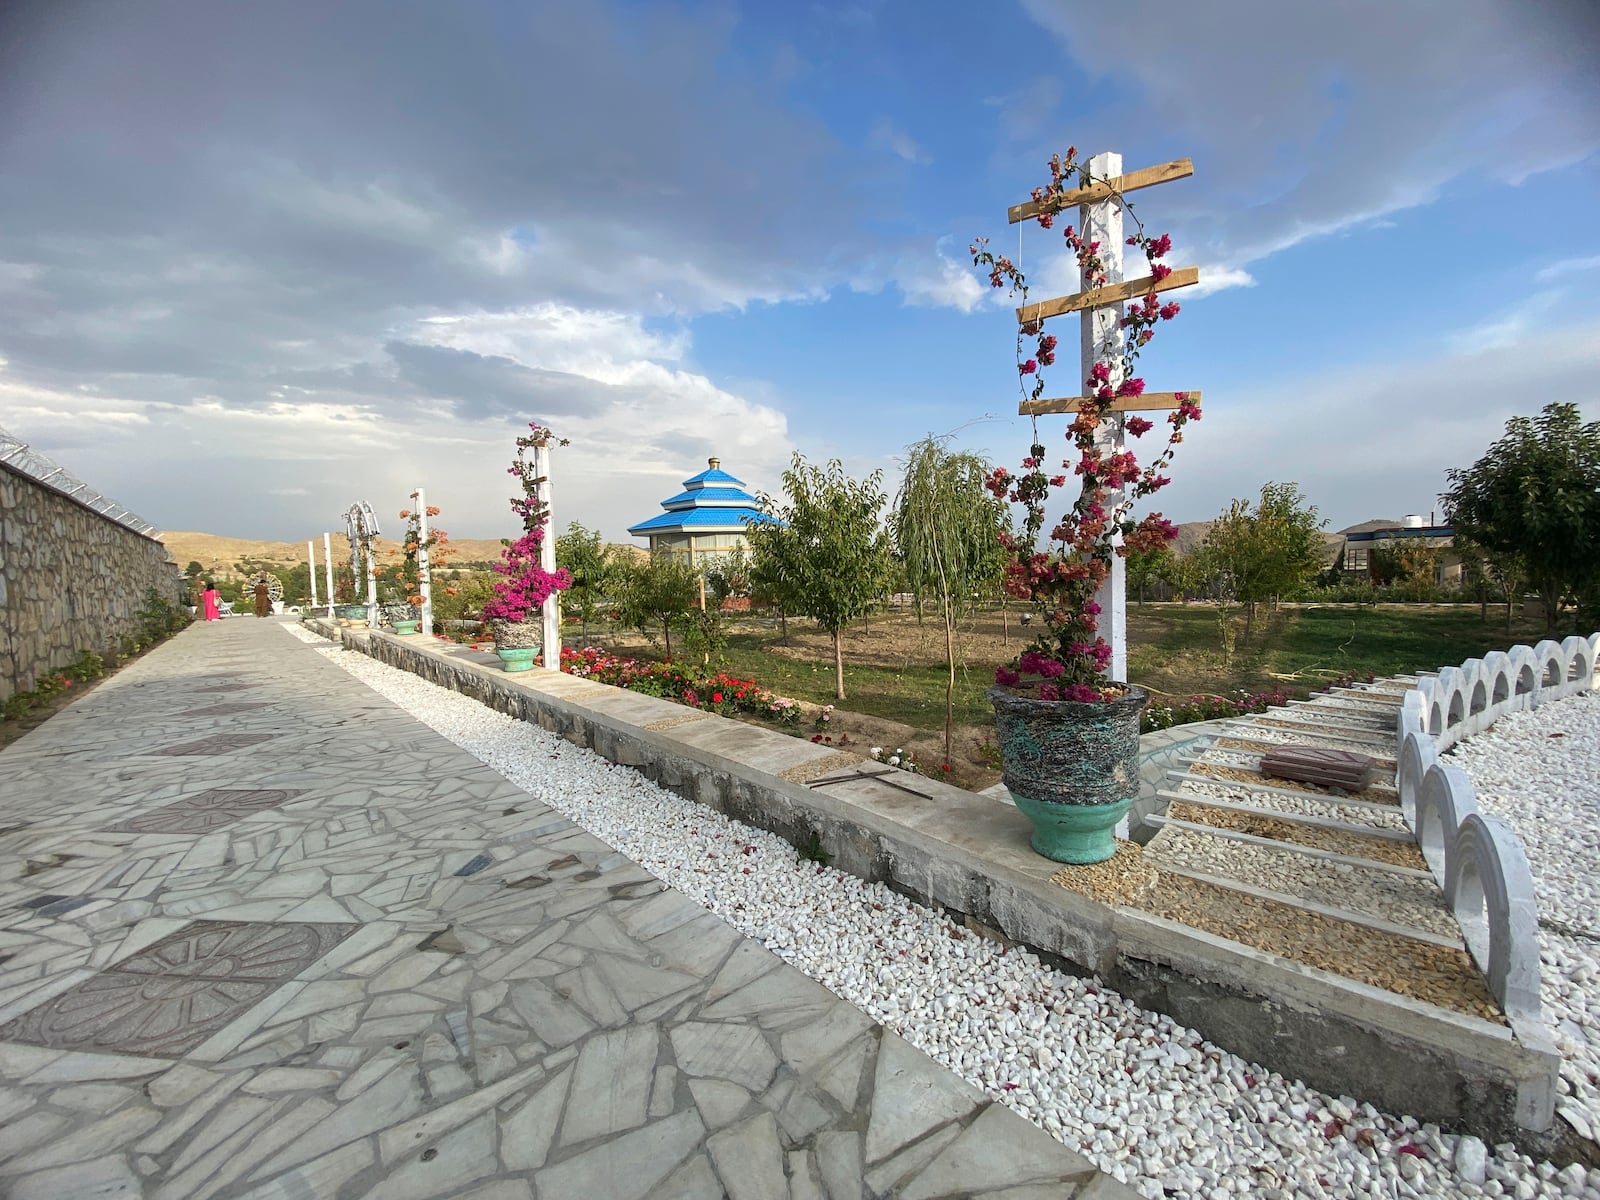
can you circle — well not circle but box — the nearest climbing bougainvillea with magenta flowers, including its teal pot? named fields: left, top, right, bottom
left=971, top=149, right=1200, bottom=862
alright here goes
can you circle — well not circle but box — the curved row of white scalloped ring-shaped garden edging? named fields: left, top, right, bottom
left=1397, top=634, right=1600, bottom=1034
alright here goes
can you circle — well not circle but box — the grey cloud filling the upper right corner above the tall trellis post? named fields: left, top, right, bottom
left=1024, top=0, right=1600, bottom=266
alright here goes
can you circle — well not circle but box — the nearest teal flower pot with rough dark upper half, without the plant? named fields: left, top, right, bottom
left=987, top=688, right=1150, bottom=862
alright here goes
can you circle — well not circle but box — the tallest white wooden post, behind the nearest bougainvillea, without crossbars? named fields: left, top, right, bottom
left=1078, top=154, right=1128, bottom=680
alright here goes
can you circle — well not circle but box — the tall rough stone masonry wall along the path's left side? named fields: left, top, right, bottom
left=0, top=464, right=181, bottom=701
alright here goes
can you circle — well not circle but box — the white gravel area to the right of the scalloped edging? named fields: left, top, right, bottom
left=1443, top=691, right=1600, bottom=1139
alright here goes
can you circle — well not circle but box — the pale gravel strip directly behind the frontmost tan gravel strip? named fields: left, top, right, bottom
left=1144, top=826, right=1461, bottom=938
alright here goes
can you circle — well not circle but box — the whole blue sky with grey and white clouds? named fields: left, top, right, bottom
left=0, top=0, right=1600, bottom=541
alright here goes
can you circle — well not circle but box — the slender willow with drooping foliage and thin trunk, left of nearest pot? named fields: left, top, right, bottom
left=890, top=434, right=1006, bottom=762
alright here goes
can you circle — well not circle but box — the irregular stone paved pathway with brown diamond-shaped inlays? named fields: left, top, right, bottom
left=0, top=621, right=1133, bottom=1200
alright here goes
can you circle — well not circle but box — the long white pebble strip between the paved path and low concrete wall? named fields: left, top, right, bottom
left=288, top=626, right=1600, bottom=1200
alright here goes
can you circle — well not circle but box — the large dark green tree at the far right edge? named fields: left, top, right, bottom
left=1438, top=403, right=1600, bottom=632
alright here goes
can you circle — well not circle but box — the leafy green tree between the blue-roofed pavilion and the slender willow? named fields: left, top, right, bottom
left=749, top=451, right=890, bottom=699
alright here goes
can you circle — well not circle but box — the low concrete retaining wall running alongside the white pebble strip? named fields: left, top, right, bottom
left=331, top=621, right=1578, bottom=1155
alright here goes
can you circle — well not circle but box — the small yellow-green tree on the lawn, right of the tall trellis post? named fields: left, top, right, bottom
left=1203, top=483, right=1326, bottom=640
